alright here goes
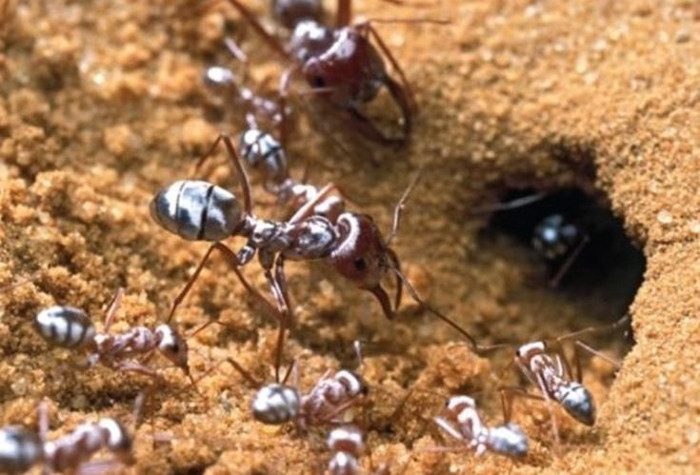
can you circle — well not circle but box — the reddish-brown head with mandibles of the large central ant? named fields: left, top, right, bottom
left=328, top=213, right=400, bottom=318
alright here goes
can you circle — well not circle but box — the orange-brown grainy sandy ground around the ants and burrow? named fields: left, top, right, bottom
left=0, top=0, right=700, bottom=473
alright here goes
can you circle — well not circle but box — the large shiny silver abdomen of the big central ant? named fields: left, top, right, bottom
left=150, top=180, right=243, bottom=241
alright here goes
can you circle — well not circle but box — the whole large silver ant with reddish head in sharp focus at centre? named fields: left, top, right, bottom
left=150, top=135, right=476, bottom=356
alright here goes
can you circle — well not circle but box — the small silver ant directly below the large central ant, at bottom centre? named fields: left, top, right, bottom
left=227, top=356, right=367, bottom=430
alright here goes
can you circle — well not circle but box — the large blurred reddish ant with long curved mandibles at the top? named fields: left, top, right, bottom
left=205, top=0, right=424, bottom=146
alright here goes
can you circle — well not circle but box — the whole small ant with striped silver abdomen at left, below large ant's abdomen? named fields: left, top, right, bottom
left=34, top=288, right=195, bottom=384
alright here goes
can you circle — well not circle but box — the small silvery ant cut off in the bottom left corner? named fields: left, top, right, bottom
left=0, top=401, right=134, bottom=473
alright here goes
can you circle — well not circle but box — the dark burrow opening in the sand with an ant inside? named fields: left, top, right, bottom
left=479, top=187, right=646, bottom=324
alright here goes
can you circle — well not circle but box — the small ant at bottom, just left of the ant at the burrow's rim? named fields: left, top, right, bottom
left=434, top=396, right=528, bottom=457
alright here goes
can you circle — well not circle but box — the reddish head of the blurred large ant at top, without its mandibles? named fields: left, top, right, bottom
left=302, top=28, right=387, bottom=107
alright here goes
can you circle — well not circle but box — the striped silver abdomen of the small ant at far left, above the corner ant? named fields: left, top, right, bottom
left=34, top=306, right=95, bottom=348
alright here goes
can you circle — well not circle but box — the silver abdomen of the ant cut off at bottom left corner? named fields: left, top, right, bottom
left=0, top=426, right=44, bottom=473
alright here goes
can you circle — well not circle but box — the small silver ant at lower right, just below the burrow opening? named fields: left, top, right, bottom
left=500, top=315, right=629, bottom=449
